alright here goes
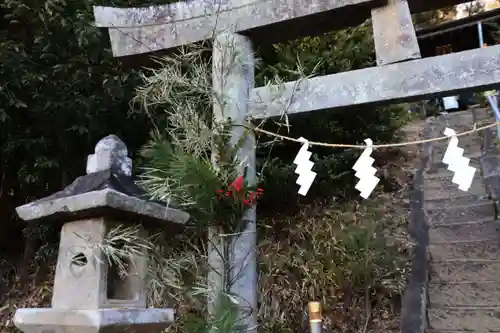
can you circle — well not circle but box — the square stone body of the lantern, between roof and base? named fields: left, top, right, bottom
left=52, top=217, right=148, bottom=310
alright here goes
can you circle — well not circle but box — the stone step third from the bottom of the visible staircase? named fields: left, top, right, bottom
left=430, top=260, right=500, bottom=283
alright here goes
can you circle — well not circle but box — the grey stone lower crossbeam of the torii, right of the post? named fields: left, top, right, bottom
left=250, top=45, right=500, bottom=118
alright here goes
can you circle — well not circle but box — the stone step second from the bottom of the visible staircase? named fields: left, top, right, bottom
left=428, top=281, right=500, bottom=307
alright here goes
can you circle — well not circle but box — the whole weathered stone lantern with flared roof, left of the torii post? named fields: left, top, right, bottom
left=14, top=135, right=189, bottom=333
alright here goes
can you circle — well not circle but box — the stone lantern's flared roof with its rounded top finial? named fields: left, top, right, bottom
left=16, top=135, right=189, bottom=224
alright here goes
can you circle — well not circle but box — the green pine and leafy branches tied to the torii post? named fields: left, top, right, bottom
left=134, top=45, right=260, bottom=233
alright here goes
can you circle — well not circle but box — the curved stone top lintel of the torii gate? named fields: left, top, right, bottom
left=94, top=0, right=472, bottom=57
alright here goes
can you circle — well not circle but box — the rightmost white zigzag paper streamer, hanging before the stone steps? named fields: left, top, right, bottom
left=443, top=128, right=476, bottom=191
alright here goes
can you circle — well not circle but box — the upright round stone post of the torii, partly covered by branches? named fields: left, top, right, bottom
left=211, top=32, right=258, bottom=333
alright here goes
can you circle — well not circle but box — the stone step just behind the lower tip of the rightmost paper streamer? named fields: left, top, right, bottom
left=424, top=182, right=487, bottom=200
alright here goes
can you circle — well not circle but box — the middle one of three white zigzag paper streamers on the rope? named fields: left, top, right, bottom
left=352, top=139, right=380, bottom=199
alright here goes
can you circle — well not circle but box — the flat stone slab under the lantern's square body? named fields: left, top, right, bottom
left=14, top=308, right=174, bottom=333
